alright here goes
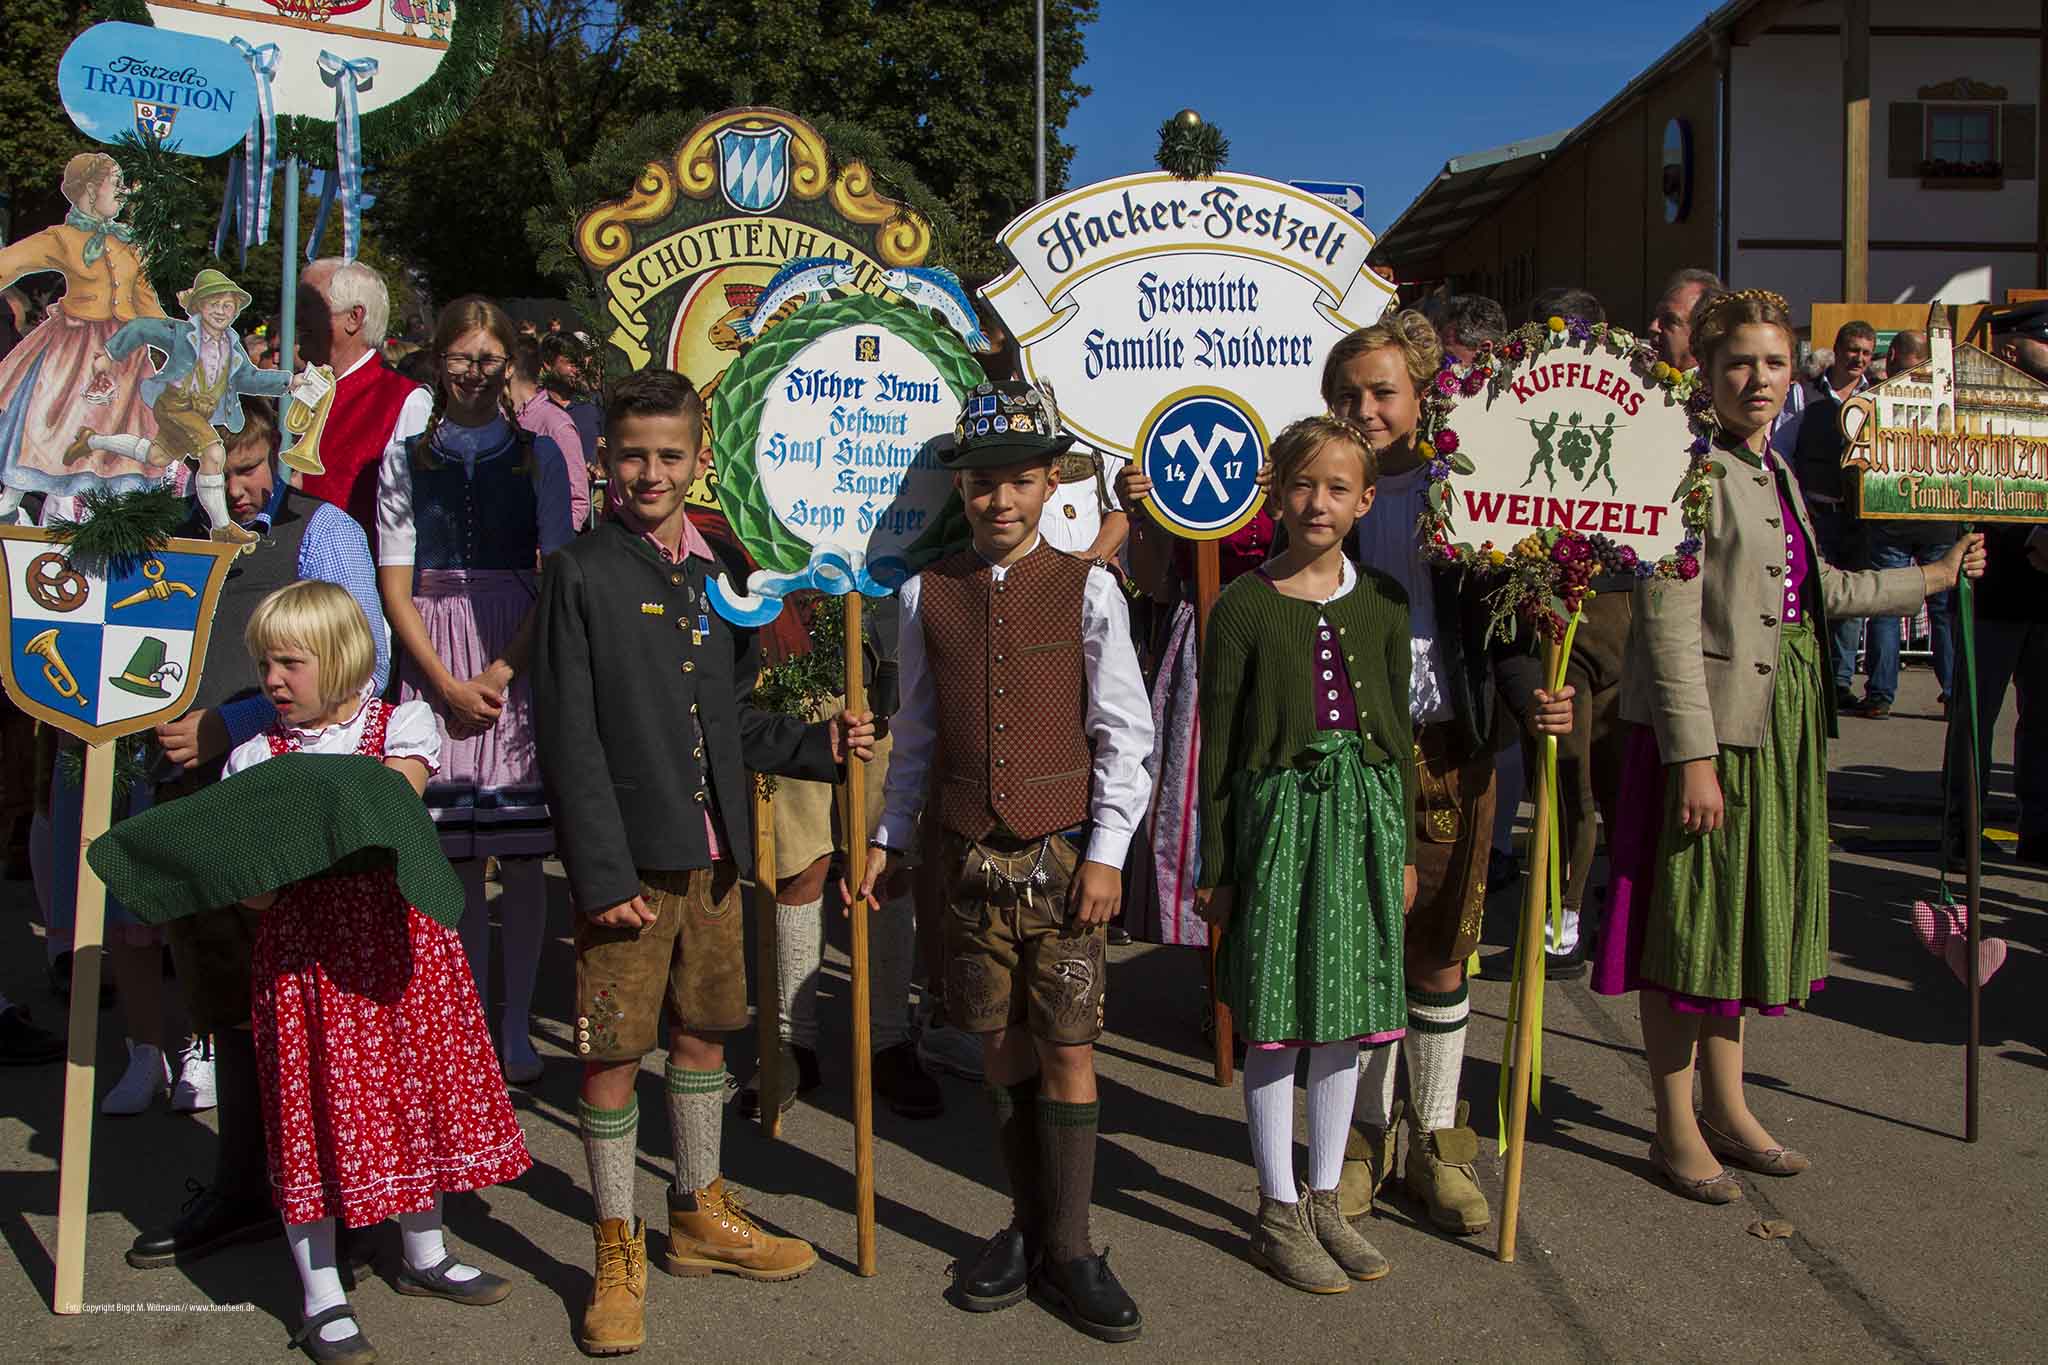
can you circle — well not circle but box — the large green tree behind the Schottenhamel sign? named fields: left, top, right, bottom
left=369, top=0, right=1096, bottom=299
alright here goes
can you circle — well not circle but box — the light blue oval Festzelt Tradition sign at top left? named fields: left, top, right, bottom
left=57, top=25, right=256, bottom=156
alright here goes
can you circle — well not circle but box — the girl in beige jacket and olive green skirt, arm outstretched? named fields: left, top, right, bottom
left=1593, top=289, right=1985, bottom=1203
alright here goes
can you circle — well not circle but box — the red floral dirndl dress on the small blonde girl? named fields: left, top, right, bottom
left=252, top=702, right=532, bottom=1228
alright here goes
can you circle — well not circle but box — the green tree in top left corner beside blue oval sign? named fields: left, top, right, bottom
left=0, top=0, right=96, bottom=237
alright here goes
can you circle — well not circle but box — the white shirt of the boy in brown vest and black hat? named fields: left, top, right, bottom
left=874, top=536, right=1153, bottom=868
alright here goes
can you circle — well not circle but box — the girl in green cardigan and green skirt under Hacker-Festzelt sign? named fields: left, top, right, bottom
left=1196, top=417, right=1415, bottom=1293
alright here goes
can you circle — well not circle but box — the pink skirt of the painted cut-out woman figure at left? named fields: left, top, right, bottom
left=0, top=311, right=166, bottom=495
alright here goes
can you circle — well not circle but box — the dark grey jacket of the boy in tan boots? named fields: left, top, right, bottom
left=532, top=520, right=840, bottom=915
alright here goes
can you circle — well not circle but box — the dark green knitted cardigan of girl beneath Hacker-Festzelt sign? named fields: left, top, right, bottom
left=1196, top=569, right=1415, bottom=888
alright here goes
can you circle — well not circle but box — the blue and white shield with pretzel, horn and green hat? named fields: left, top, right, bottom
left=0, top=526, right=240, bottom=743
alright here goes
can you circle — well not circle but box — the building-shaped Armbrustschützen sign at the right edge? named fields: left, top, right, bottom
left=1839, top=323, right=2048, bottom=524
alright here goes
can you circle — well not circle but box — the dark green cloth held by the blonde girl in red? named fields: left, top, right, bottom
left=86, top=753, right=463, bottom=929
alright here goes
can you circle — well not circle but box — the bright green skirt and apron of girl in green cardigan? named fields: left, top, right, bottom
left=1219, top=731, right=1407, bottom=1044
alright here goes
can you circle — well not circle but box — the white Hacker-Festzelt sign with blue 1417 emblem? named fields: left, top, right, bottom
left=983, top=174, right=1395, bottom=485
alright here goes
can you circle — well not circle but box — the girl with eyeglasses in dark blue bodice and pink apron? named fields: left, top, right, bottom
left=377, top=297, right=573, bottom=1085
